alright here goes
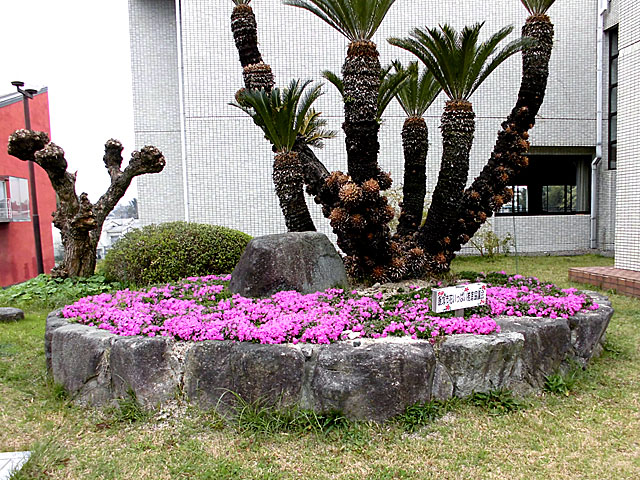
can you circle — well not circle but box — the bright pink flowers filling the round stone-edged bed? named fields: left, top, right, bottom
left=62, top=272, right=598, bottom=344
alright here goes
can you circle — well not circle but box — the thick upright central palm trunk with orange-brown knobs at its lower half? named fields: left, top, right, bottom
left=330, top=41, right=394, bottom=280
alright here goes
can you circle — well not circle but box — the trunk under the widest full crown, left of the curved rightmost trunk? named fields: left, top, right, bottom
left=417, top=101, right=475, bottom=272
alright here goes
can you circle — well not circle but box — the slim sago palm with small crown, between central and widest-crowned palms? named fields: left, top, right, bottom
left=394, top=62, right=442, bottom=236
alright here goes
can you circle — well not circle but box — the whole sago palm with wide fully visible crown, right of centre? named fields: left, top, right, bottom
left=389, top=23, right=526, bottom=271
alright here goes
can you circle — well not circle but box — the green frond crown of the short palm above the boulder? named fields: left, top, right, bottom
left=231, top=80, right=322, bottom=152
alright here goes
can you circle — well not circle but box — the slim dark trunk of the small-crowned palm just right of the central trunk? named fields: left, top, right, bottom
left=397, top=117, right=429, bottom=236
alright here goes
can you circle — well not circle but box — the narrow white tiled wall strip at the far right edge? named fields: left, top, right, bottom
left=615, top=0, right=640, bottom=271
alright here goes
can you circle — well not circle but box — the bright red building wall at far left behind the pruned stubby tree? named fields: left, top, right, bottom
left=0, top=91, right=56, bottom=287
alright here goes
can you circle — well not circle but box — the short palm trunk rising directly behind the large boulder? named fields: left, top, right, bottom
left=273, top=152, right=316, bottom=232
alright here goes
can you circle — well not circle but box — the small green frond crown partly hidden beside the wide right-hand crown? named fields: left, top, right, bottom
left=393, top=61, right=442, bottom=117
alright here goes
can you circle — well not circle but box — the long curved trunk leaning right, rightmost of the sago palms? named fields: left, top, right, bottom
left=446, top=15, right=553, bottom=262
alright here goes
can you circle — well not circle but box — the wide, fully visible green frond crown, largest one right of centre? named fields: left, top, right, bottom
left=389, top=22, right=531, bottom=101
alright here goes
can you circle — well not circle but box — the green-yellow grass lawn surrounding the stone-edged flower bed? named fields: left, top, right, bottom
left=0, top=256, right=640, bottom=480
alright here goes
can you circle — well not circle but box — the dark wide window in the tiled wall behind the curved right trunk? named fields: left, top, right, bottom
left=498, top=154, right=591, bottom=215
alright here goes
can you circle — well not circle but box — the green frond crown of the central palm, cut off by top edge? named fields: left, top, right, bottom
left=283, top=0, right=396, bottom=42
